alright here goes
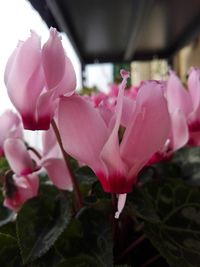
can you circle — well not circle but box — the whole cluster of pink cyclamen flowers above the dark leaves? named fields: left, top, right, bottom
left=0, top=29, right=200, bottom=216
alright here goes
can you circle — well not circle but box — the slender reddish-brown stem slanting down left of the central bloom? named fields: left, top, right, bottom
left=51, top=120, right=83, bottom=210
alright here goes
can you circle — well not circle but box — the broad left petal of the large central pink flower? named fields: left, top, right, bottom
left=58, top=95, right=108, bottom=173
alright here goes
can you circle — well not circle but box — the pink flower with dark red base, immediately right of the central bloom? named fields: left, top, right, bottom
left=148, top=71, right=191, bottom=165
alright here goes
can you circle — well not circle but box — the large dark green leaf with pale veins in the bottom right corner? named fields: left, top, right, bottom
left=130, top=180, right=200, bottom=267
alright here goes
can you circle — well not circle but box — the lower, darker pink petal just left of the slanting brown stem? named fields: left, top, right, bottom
left=42, top=158, right=73, bottom=190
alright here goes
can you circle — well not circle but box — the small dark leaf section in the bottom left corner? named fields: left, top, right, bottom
left=0, top=233, right=21, bottom=267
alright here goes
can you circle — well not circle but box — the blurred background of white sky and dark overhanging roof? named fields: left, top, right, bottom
left=0, top=0, right=200, bottom=145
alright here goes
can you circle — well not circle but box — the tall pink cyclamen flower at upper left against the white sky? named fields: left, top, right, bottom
left=5, top=28, right=76, bottom=130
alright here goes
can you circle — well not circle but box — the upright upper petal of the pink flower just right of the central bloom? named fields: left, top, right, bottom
left=166, top=72, right=192, bottom=116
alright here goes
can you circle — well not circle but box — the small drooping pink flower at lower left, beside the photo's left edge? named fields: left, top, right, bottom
left=4, top=138, right=39, bottom=211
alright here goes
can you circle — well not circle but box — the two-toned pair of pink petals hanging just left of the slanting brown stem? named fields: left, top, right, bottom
left=41, top=127, right=73, bottom=190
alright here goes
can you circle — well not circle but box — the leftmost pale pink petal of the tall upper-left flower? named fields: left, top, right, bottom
left=5, top=32, right=44, bottom=116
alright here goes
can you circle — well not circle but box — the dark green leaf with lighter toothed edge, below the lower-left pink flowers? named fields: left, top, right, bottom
left=17, top=186, right=71, bottom=264
